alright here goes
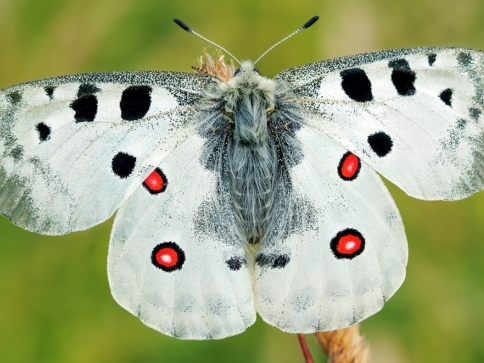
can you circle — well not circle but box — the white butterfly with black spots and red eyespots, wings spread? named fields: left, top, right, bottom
left=0, top=17, right=484, bottom=339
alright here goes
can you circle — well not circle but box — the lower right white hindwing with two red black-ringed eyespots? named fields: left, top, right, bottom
left=254, top=126, right=407, bottom=333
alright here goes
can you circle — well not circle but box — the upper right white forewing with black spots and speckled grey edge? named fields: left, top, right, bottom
left=278, top=48, right=484, bottom=199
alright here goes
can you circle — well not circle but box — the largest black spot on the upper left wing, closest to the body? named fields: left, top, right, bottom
left=119, top=86, right=152, bottom=121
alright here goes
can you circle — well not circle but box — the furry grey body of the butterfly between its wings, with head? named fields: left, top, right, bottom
left=199, top=62, right=302, bottom=244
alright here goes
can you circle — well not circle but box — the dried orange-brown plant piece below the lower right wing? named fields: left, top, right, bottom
left=314, top=324, right=370, bottom=363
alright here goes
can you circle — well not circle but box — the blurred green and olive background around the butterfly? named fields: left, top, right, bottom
left=0, top=0, right=484, bottom=363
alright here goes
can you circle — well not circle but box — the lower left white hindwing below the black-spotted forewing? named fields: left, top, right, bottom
left=108, top=135, right=255, bottom=339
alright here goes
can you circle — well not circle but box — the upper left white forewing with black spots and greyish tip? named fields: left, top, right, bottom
left=0, top=72, right=212, bottom=234
